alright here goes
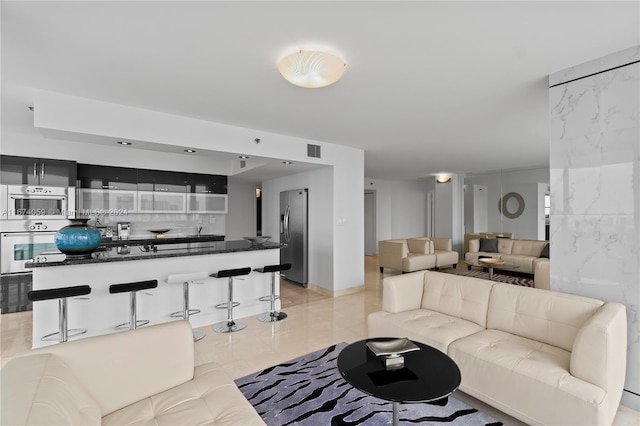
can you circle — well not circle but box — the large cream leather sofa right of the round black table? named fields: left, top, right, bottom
left=368, top=271, right=627, bottom=426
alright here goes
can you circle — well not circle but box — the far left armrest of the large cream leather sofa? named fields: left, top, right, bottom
left=382, top=272, right=424, bottom=313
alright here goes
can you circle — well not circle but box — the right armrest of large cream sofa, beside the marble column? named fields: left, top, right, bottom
left=569, top=302, right=627, bottom=394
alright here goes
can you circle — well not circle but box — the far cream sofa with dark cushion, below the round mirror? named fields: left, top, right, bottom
left=464, top=238, right=549, bottom=274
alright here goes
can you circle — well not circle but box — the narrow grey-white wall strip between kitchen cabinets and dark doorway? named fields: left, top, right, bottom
left=226, top=180, right=256, bottom=241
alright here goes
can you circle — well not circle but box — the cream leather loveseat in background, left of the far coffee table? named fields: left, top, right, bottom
left=378, top=237, right=459, bottom=273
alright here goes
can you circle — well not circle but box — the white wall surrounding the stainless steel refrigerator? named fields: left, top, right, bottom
left=262, top=167, right=336, bottom=290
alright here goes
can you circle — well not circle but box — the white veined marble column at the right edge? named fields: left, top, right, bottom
left=549, top=46, right=640, bottom=410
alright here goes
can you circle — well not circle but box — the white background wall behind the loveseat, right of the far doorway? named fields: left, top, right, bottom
left=364, top=178, right=427, bottom=241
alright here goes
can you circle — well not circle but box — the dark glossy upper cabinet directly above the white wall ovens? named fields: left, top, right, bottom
left=0, top=155, right=77, bottom=186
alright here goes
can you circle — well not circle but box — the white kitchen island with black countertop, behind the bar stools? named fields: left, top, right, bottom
left=27, top=238, right=281, bottom=348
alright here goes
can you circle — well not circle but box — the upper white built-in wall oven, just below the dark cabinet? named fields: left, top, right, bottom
left=0, top=185, right=76, bottom=221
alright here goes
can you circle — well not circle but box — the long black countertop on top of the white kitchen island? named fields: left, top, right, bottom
left=25, top=241, right=282, bottom=268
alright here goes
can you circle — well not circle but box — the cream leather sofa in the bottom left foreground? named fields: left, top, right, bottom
left=0, top=320, right=264, bottom=426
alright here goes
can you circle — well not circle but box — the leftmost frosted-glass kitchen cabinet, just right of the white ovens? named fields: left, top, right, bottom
left=78, top=188, right=138, bottom=215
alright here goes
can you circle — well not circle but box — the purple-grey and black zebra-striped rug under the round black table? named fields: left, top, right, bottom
left=235, top=343, right=502, bottom=426
